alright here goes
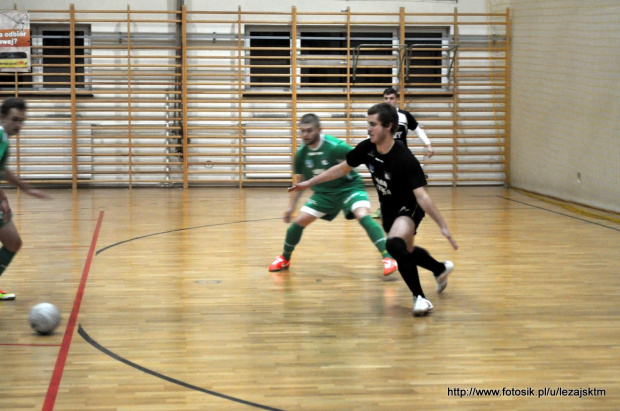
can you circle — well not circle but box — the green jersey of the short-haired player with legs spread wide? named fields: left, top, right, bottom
left=294, top=134, right=364, bottom=193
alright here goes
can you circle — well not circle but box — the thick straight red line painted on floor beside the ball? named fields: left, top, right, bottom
left=43, top=211, right=103, bottom=411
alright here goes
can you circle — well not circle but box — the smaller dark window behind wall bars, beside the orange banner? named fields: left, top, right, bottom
left=0, top=24, right=90, bottom=91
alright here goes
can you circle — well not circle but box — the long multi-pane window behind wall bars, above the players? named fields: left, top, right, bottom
left=246, top=26, right=450, bottom=92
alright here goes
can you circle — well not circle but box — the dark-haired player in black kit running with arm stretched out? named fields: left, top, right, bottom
left=289, top=103, right=458, bottom=316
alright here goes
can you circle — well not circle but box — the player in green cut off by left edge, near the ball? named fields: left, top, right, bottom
left=0, top=97, right=47, bottom=300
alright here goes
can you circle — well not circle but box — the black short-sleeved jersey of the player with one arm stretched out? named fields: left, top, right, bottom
left=347, top=139, right=426, bottom=213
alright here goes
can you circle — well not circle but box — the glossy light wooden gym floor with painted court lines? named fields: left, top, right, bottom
left=0, top=187, right=620, bottom=410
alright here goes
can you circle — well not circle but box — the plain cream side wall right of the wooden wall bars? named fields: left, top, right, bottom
left=492, top=0, right=620, bottom=212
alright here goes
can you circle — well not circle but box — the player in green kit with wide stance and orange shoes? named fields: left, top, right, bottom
left=269, top=114, right=398, bottom=278
